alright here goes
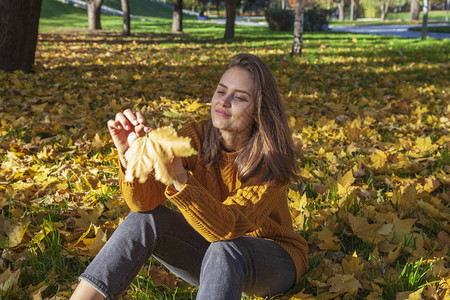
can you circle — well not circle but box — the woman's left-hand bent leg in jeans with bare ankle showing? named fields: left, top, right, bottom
left=74, top=206, right=209, bottom=299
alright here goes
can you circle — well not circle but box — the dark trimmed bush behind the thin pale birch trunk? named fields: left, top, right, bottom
left=265, top=8, right=330, bottom=31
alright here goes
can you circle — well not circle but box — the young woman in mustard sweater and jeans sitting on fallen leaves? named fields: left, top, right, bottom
left=71, top=54, right=308, bottom=300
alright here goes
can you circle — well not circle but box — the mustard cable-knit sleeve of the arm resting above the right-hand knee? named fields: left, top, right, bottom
left=165, top=176, right=287, bottom=242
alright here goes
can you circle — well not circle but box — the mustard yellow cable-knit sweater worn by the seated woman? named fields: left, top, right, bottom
left=119, top=121, right=308, bottom=283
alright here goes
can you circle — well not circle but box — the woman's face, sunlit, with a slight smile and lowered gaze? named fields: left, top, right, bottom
left=211, top=67, right=256, bottom=138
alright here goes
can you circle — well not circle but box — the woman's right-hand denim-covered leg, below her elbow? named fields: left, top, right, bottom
left=197, top=236, right=296, bottom=300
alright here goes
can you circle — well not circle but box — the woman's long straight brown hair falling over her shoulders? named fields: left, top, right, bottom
left=202, top=53, right=296, bottom=183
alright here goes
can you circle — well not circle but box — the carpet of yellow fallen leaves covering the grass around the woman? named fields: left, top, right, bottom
left=0, top=34, right=450, bottom=299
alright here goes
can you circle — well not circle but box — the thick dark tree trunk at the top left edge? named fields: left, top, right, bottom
left=0, top=0, right=42, bottom=72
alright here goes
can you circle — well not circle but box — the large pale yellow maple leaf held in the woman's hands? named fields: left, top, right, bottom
left=125, top=126, right=197, bottom=185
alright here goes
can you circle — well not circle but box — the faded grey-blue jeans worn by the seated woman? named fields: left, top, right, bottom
left=80, top=206, right=296, bottom=300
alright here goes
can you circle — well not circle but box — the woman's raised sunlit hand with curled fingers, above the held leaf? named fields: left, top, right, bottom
left=108, top=109, right=151, bottom=168
